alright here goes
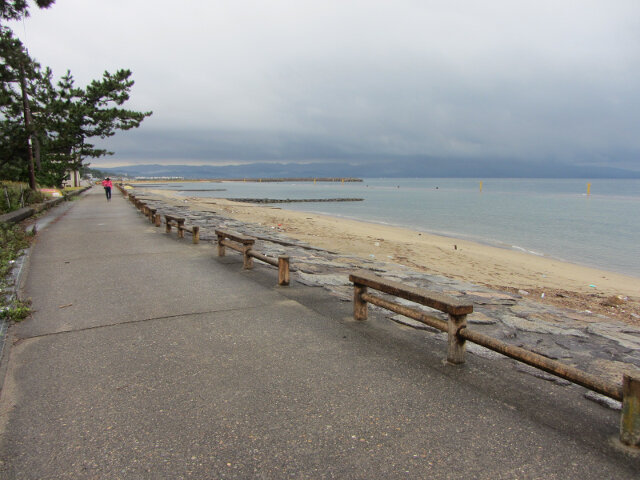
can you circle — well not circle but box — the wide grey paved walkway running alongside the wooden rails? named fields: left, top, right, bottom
left=0, top=189, right=640, bottom=479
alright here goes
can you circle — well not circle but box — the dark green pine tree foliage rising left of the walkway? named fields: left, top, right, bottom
left=0, top=0, right=152, bottom=187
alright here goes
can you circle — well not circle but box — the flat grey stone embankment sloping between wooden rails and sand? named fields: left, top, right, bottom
left=131, top=191, right=640, bottom=408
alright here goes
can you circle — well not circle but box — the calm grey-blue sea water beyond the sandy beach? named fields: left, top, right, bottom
left=145, top=178, right=640, bottom=282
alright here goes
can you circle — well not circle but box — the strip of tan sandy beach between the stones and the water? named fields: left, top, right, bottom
left=147, top=189, right=640, bottom=325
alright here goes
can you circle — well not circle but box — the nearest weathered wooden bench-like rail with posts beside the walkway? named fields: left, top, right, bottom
left=349, top=271, right=640, bottom=448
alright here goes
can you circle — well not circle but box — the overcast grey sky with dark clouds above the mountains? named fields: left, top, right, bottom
left=12, top=0, right=640, bottom=170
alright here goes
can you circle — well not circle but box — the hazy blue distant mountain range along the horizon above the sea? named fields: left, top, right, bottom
left=99, top=158, right=640, bottom=179
